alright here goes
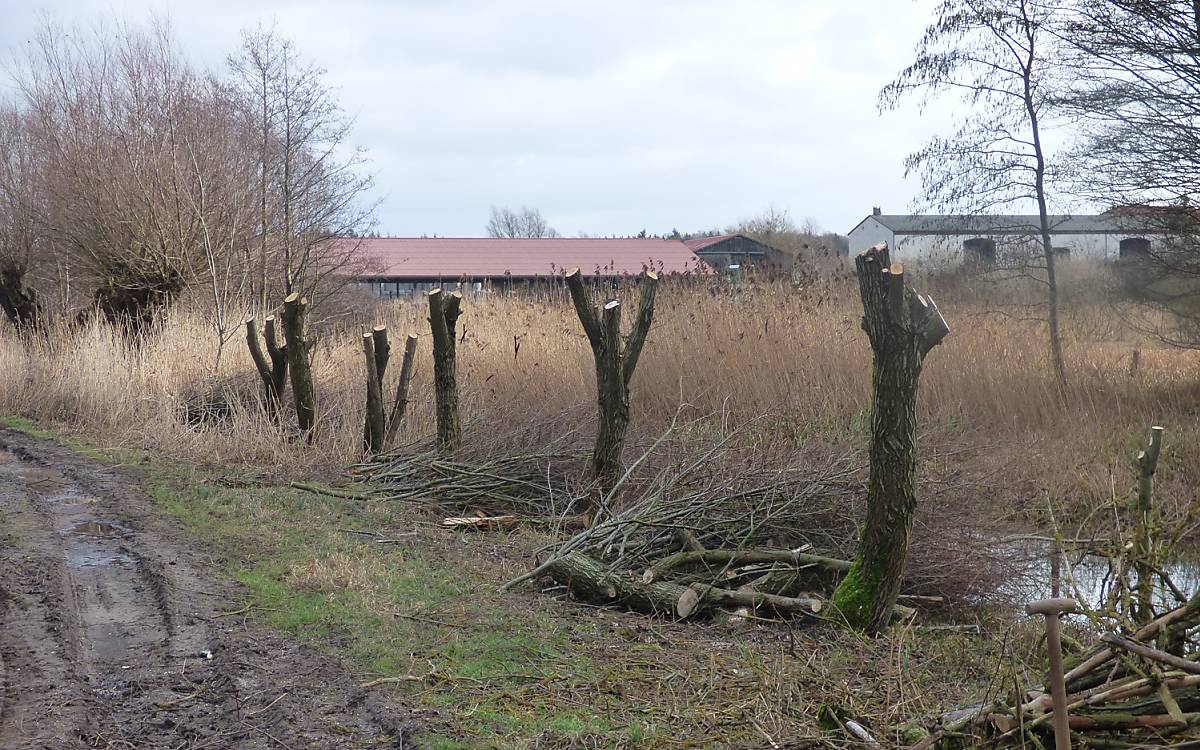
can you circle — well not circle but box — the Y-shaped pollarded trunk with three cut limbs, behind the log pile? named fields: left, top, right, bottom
left=566, top=269, right=659, bottom=491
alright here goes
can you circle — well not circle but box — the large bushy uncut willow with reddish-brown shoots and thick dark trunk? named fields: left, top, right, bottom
left=17, top=24, right=204, bottom=330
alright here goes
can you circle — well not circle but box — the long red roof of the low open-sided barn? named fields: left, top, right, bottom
left=348, top=238, right=709, bottom=278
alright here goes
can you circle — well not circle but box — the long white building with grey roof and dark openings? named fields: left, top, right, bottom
left=850, top=209, right=1164, bottom=263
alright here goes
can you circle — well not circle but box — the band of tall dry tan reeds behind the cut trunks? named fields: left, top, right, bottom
left=0, top=260, right=1200, bottom=489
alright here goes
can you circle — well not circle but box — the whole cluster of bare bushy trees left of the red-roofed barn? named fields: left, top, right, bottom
left=0, top=23, right=373, bottom=336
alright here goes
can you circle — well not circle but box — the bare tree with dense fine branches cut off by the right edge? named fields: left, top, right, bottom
left=1060, top=0, right=1200, bottom=347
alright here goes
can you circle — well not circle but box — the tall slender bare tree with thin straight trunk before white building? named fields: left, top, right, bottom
left=880, top=0, right=1067, bottom=385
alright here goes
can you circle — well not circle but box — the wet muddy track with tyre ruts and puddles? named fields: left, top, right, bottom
left=0, top=430, right=409, bottom=750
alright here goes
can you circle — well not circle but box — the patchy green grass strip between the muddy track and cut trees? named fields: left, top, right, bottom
left=5, top=420, right=1032, bottom=750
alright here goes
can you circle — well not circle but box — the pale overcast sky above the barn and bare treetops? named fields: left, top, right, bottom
left=0, top=0, right=947, bottom=236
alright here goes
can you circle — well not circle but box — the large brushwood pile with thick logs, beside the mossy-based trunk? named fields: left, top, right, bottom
left=496, top=442, right=892, bottom=619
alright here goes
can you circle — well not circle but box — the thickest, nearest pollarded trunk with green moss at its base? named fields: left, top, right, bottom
left=833, top=245, right=949, bottom=634
